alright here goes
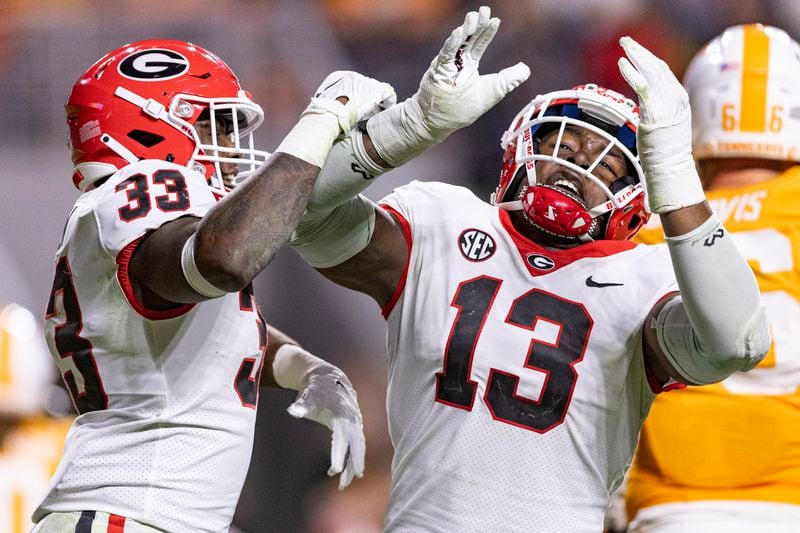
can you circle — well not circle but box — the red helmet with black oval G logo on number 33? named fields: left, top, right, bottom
left=65, top=39, right=269, bottom=191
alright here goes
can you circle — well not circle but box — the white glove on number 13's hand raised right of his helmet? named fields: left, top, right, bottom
left=618, top=37, right=705, bottom=214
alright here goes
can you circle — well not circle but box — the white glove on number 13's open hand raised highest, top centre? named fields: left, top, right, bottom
left=367, top=6, right=530, bottom=167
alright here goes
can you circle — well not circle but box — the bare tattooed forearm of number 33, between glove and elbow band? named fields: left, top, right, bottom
left=195, top=153, right=319, bottom=292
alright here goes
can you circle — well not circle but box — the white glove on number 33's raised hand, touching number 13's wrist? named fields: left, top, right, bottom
left=275, top=70, right=397, bottom=168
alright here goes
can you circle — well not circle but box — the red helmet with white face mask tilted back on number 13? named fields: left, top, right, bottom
left=492, top=84, right=650, bottom=242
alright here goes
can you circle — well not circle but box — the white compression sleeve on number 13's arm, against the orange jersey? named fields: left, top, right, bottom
left=656, top=215, right=770, bottom=385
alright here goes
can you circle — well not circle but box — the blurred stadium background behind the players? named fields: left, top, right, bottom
left=0, top=0, right=800, bottom=533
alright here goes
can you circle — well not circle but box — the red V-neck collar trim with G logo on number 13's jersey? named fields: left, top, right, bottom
left=498, top=209, right=636, bottom=276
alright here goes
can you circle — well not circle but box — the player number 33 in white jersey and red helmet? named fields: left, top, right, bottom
left=33, top=40, right=394, bottom=532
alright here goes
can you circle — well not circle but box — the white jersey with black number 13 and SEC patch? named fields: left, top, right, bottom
left=383, top=182, right=677, bottom=532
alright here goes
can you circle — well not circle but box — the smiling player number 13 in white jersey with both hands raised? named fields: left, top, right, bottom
left=292, top=8, right=769, bottom=532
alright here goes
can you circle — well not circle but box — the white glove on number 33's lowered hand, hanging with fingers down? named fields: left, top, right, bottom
left=273, top=344, right=366, bottom=490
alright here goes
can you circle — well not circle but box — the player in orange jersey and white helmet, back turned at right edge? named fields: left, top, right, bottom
left=626, top=24, right=800, bottom=533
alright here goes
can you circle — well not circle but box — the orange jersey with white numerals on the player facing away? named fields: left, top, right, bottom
left=626, top=167, right=800, bottom=517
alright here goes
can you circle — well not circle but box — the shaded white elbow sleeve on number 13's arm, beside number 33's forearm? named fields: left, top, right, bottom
left=289, top=195, right=375, bottom=268
